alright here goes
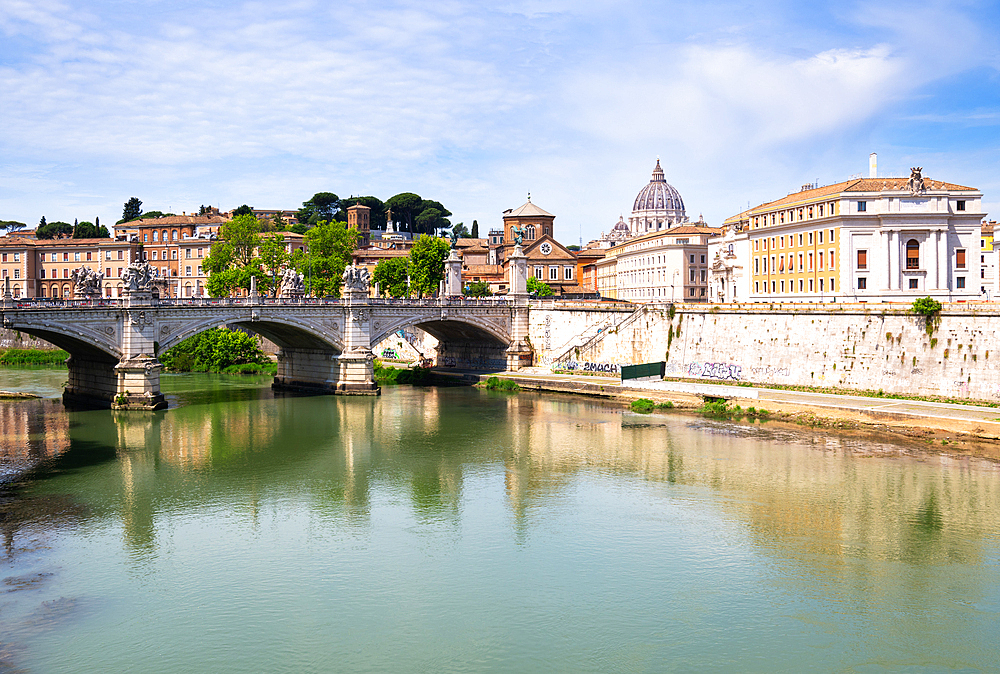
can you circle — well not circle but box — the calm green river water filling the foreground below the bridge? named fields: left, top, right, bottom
left=0, top=369, right=1000, bottom=674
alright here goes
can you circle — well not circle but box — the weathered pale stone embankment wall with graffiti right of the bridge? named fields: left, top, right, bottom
left=531, top=304, right=1000, bottom=402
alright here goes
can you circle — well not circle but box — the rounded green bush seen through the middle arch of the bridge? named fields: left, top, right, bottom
left=160, top=328, right=277, bottom=374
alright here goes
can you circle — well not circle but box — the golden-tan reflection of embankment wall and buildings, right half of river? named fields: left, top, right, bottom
left=505, top=396, right=1000, bottom=564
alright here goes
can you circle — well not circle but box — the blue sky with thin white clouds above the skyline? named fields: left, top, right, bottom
left=0, top=0, right=1000, bottom=243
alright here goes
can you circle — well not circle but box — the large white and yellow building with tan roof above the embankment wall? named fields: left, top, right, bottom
left=726, top=168, right=985, bottom=302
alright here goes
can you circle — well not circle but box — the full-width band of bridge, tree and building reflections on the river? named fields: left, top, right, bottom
left=0, top=387, right=1000, bottom=569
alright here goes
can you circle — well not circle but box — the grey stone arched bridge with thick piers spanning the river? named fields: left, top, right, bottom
left=0, top=291, right=531, bottom=410
